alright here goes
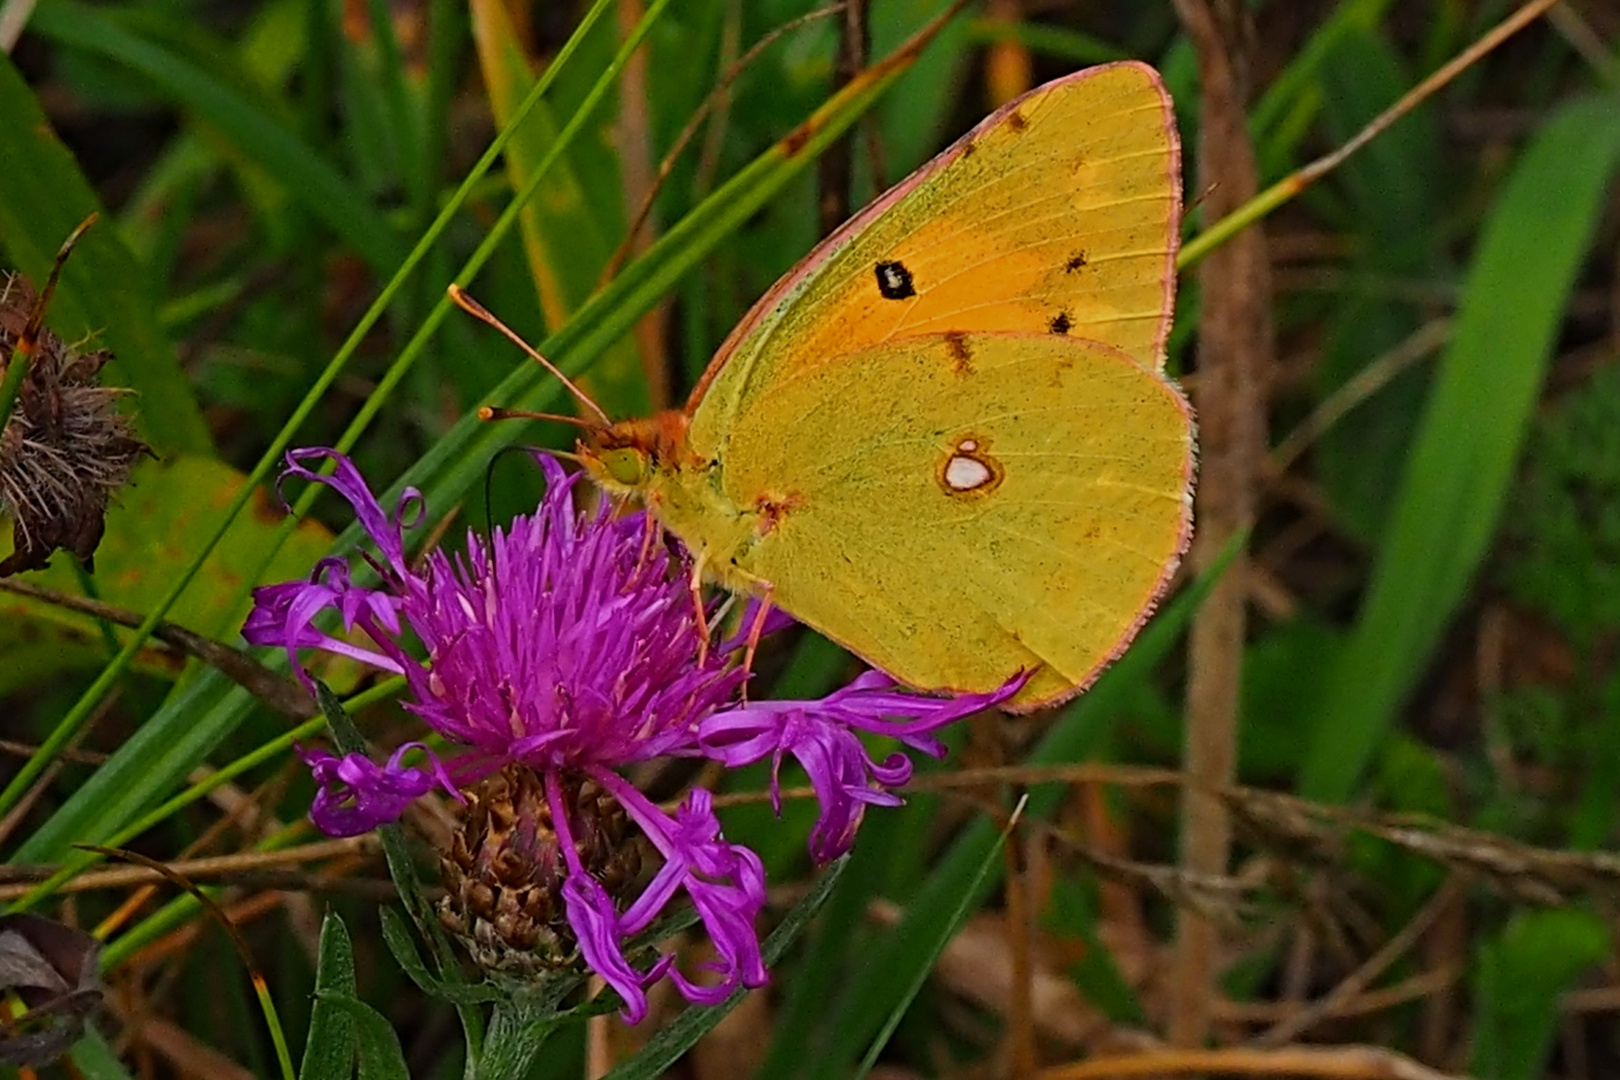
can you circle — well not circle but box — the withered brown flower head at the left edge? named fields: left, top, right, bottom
left=0, top=274, right=151, bottom=578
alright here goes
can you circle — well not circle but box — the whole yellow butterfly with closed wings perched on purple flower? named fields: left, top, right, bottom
left=560, top=63, right=1194, bottom=709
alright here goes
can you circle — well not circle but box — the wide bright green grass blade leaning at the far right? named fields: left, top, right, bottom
left=1299, top=97, right=1620, bottom=801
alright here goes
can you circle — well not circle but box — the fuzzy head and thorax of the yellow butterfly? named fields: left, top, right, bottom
left=578, top=410, right=774, bottom=591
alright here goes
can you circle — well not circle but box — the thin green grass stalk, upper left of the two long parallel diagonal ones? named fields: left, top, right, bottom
left=0, top=0, right=609, bottom=835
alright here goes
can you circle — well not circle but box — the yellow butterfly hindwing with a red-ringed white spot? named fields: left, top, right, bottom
left=719, top=332, right=1192, bottom=708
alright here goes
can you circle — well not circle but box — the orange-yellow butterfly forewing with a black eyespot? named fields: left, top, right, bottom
left=689, top=63, right=1181, bottom=455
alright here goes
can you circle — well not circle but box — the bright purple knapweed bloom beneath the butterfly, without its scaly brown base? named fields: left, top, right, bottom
left=243, top=449, right=1022, bottom=1022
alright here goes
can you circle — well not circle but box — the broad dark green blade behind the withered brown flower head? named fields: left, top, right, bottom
left=0, top=55, right=212, bottom=453
